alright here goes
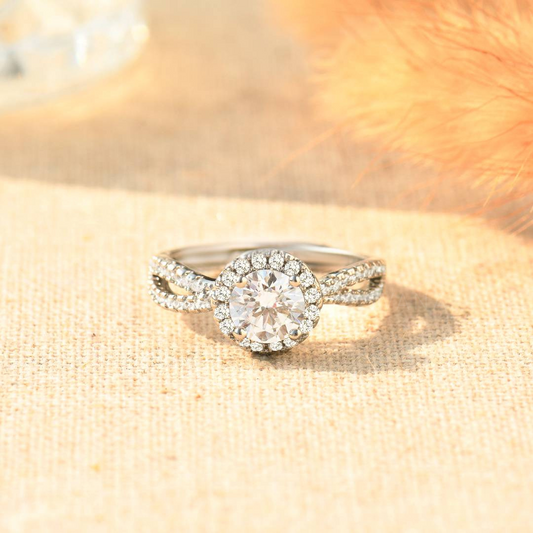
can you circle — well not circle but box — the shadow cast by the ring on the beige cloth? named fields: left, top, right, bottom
left=184, top=283, right=458, bottom=374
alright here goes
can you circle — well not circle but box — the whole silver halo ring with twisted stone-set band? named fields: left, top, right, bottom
left=149, top=243, right=386, bottom=354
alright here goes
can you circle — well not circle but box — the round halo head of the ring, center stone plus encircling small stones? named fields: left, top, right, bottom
left=212, top=250, right=322, bottom=352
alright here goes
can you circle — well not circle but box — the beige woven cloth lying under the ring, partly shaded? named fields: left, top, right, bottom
left=0, top=0, right=533, bottom=533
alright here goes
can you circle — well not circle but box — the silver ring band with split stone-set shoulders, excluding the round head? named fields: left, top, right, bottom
left=149, top=242, right=386, bottom=312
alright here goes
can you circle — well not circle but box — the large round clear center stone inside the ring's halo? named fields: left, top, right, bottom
left=229, top=269, right=305, bottom=343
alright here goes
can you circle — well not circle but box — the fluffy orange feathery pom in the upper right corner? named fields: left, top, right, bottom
left=275, top=0, right=533, bottom=227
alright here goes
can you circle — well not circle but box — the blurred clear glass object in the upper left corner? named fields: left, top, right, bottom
left=0, top=0, right=147, bottom=109
